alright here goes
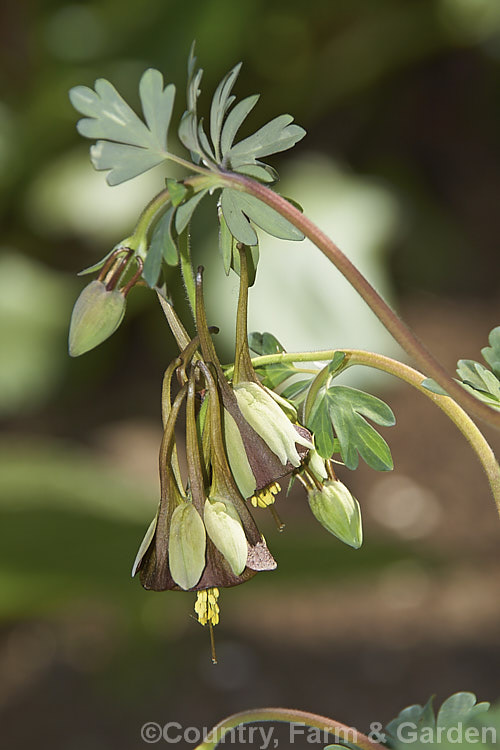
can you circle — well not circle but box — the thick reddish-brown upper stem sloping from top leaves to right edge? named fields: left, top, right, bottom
left=223, top=172, right=500, bottom=429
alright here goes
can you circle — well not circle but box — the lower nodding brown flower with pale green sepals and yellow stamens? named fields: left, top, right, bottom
left=132, top=339, right=276, bottom=656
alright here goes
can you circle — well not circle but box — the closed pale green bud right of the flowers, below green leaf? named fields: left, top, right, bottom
left=308, top=479, right=363, bottom=549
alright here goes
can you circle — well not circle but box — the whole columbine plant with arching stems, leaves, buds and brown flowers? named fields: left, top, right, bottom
left=69, top=45, right=500, bottom=659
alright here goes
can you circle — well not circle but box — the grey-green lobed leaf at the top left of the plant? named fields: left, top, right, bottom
left=69, top=68, right=175, bottom=185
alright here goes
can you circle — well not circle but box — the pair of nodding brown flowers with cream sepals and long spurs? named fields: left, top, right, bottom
left=126, top=247, right=361, bottom=660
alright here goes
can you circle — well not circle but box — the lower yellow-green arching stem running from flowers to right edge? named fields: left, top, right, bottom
left=245, top=349, right=500, bottom=514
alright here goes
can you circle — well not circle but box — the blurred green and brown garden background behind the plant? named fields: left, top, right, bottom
left=0, top=0, right=500, bottom=750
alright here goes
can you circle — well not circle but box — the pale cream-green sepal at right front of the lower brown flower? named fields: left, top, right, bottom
left=204, top=495, right=248, bottom=576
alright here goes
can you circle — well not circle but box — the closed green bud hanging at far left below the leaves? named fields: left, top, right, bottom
left=69, top=281, right=126, bottom=357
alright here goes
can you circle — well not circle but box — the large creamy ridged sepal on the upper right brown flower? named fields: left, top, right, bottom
left=234, top=383, right=314, bottom=466
